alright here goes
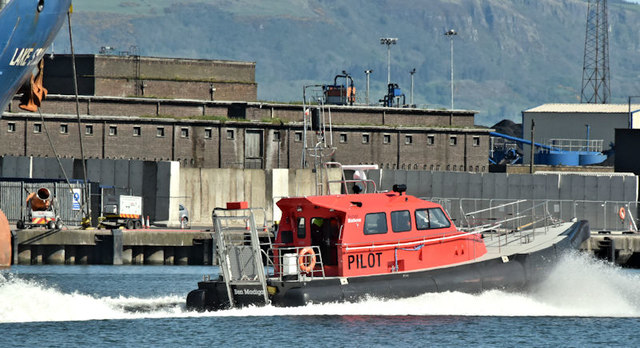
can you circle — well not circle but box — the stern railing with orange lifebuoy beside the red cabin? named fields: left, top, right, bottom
left=266, top=246, right=326, bottom=281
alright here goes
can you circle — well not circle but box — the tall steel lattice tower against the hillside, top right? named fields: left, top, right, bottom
left=580, top=0, right=611, bottom=104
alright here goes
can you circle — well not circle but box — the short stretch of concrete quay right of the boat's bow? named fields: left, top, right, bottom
left=580, top=231, right=640, bottom=268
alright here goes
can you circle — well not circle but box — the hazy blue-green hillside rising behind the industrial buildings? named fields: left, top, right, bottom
left=55, top=0, right=640, bottom=125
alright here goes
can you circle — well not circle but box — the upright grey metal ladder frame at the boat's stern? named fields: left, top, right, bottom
left=212, top=208, right=271, bottom=308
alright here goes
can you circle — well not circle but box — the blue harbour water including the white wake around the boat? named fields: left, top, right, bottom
left=0, top=255, right=640, bottom=347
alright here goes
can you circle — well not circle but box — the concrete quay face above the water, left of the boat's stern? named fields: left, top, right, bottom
left=11, top=229, right=214, bottom=265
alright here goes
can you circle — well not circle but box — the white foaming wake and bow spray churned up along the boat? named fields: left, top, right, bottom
left=0, top=253, right=640, bottom=323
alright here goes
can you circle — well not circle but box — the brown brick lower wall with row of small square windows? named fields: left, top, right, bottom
left=0, top=114, right=489, bottom=172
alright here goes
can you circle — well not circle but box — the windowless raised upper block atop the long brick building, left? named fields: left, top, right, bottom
left=44, top=54, right=258, bottom=101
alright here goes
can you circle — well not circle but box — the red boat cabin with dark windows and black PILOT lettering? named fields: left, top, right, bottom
left=274, top=185, right=487, bottom=277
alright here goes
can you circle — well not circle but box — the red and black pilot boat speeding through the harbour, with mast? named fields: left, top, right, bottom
left=186, top=97, right=590, bottom=311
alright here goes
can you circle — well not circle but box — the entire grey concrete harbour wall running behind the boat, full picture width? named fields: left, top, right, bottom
left=0, top=156, right=638, bottom=229
